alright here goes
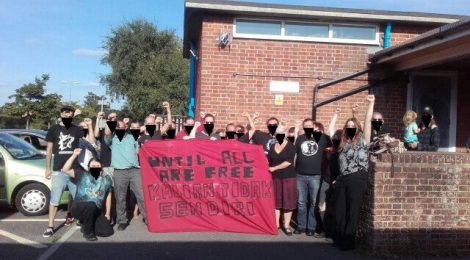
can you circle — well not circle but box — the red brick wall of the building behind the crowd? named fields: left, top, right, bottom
left=196, top=15, right=436, bottom=135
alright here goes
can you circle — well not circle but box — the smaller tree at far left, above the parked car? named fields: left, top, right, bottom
left=2, top=74, right=61, bottom=128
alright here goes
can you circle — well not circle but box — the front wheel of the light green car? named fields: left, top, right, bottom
left=15, top=183, right=50, bottom=216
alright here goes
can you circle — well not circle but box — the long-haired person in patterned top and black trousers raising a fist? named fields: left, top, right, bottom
left=334, top=95, right=375, bottom=250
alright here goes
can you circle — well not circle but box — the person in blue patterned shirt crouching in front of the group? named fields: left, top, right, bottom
left=62, top=148, right=114, bottom=241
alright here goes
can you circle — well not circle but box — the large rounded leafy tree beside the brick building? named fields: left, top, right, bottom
left=101, top=20, right=188, bottom=119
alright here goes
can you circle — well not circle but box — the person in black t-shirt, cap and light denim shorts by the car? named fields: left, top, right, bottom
left=43, top=105, right=83, bottom=237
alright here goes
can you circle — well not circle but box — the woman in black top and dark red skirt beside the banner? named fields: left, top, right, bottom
left=268, top=126, right=297, bottom=236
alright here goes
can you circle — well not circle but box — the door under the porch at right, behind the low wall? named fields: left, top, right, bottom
left=407, top=71, right=457, bottom=152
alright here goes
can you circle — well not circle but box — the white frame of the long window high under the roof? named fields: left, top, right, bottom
left=232, top=17, right=380, bottom=46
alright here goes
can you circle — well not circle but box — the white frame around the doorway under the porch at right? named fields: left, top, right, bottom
left=406, top=70, right=458, bottom=152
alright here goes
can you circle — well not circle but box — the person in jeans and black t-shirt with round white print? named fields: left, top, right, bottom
left=294, top=118, right=331, bottom=236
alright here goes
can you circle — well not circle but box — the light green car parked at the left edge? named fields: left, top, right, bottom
left=0, top=133, right=69, bottom=216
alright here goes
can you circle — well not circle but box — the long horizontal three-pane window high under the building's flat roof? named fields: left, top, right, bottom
left=233, top=18, right=379, bottom=45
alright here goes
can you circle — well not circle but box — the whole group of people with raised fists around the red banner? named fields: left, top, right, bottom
left=43, top=95, right=439, bottom=249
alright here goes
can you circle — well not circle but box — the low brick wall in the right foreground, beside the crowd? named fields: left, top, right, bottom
left=360, top=152, right=470, bottom=256
